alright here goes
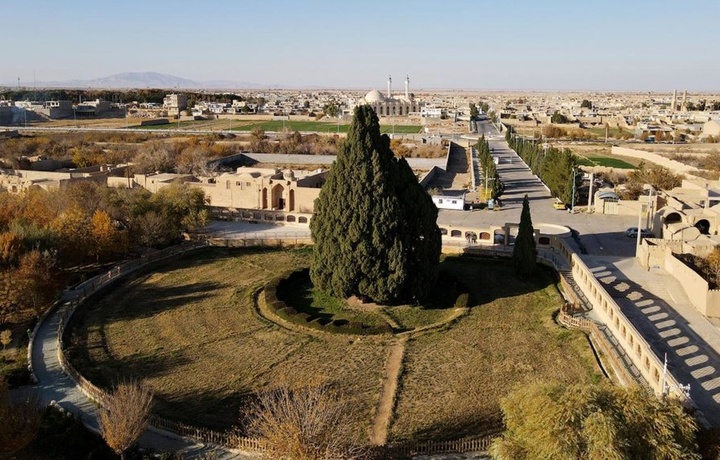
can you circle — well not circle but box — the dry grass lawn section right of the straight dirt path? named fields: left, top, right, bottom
left=391, top=260, right=599, bottom=440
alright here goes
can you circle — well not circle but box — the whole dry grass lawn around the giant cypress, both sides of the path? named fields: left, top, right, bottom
left=64, top=249, right=597, bottom=441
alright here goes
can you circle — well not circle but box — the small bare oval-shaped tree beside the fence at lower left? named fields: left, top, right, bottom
left=100, top=380, right=153, bottom=459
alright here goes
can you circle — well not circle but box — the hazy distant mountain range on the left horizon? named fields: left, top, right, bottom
left=4, top=72, right=280, bottom=90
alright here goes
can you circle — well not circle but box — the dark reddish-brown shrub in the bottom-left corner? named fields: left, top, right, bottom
left=0, top=378, right=42, bottom=458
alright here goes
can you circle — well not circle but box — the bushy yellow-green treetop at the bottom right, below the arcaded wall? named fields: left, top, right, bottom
left=492, top=383, right=700, bottom=460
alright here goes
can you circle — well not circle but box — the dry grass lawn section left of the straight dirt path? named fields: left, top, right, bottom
left=73, top=250, right=386, bottom=429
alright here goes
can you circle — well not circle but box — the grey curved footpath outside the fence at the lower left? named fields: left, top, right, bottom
left=31, top=292, right=250, bottom=460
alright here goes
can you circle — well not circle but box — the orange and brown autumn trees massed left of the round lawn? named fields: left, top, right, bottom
left=0, top=182, right=208, bottom=324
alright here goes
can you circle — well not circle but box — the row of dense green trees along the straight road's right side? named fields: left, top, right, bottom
left=505, top=127, right=581, bottom=203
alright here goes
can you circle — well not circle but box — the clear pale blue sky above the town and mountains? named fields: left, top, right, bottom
left=0, top=0, right=720, bottom=91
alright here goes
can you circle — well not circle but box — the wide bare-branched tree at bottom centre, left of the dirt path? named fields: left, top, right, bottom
left=247, top=385, right=365, bottom=460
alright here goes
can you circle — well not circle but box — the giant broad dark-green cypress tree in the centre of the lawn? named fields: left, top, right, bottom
left=310, top=105, right=441, bottom=303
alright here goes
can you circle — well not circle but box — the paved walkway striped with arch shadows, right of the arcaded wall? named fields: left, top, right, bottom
left=583, top=256, right=720, bottom=427
